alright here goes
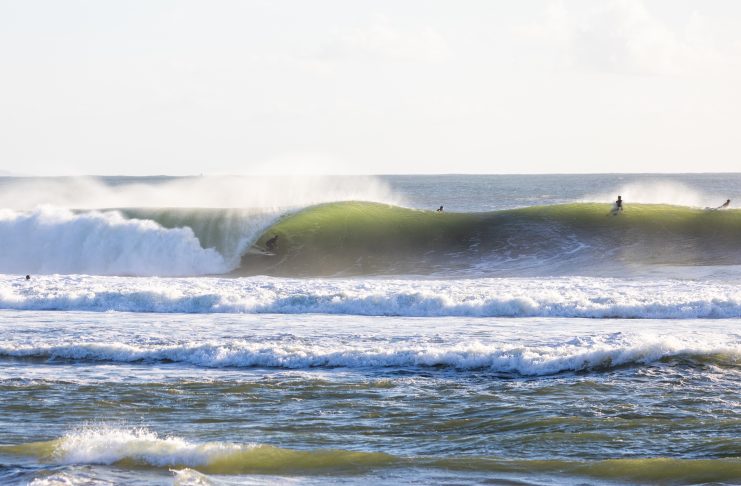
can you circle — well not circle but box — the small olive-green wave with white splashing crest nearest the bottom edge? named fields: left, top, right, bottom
left=5, top=426, right=741, bottom=480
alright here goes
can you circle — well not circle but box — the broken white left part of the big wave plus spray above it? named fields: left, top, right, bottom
left=0, top=176, right=401, bottom=276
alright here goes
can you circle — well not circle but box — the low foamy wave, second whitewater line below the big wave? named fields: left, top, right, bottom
left=0, top=333, right=741, bottom=376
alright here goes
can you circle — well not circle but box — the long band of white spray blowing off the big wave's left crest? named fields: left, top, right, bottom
left=0, top=176, right=403, bottom=210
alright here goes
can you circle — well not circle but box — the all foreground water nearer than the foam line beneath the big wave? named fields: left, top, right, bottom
left=0, top=311, right=741, bottom=484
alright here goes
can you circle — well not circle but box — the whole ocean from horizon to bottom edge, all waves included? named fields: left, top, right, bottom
left=0, top=174, right=741, bottom=485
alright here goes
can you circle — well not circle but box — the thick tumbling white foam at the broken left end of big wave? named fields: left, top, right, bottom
left=0, top=206, right=229, bottom=276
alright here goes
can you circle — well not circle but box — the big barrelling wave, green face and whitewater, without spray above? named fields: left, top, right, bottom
left=0, top=202, right=741, bottom=277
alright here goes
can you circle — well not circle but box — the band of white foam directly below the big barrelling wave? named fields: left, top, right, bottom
left=0, top=276, right=741, bottom=319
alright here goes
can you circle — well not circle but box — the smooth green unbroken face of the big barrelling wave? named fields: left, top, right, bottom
left=237, top=202, right=741, bottom=276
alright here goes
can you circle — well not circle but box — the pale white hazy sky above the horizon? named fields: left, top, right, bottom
left=0, top=0, right=741, bottom=175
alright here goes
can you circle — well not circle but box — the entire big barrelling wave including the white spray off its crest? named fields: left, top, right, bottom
left=0, top=176, right=741, bottom=278
